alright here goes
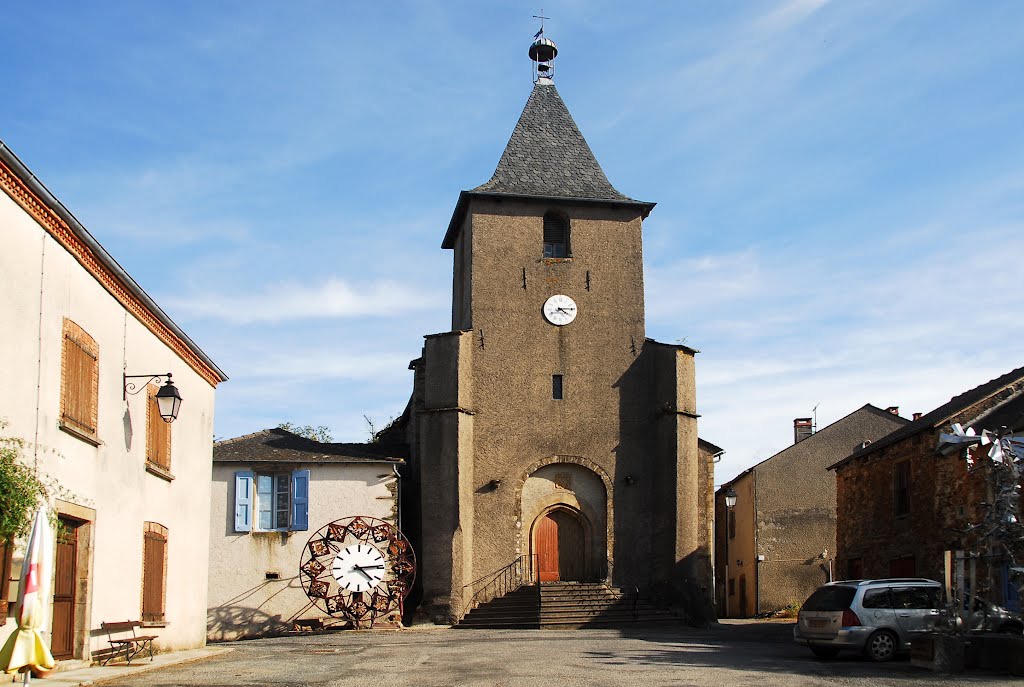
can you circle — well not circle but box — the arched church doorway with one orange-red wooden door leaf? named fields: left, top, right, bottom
left=530, top=507, right=594, bottom=582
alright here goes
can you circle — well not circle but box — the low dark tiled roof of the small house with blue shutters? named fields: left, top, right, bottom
left=213, top=428, right=409, bottom=463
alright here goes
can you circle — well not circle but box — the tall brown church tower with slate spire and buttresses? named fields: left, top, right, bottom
left=406, top=41, right=714, bottom=621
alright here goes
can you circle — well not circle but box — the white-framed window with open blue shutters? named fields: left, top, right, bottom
left=234, top=470, right=309, bottom=532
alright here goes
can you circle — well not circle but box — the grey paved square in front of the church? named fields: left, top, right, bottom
left=97, top=621, right=1024, bottom=687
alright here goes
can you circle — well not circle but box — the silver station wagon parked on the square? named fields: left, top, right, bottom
left=793, top=577, right=942, bottom=661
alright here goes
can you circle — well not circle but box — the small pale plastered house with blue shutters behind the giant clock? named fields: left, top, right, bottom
left=208, top=428, right=408, bottom=641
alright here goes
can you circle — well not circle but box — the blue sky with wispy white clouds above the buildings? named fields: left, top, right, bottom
left=0, top=0, right=1024, bottom=481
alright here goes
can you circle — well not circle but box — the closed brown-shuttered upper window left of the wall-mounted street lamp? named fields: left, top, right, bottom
left=60, top=317, right=99, bottom=443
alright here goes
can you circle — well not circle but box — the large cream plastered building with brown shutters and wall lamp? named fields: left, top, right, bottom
left=0, top=142, right=227, bottom=665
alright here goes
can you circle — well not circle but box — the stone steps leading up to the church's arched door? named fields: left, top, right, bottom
left=456, top=583, right=677, bottom=629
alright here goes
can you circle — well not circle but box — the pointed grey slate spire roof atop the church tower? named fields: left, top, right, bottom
left=473, top=79, right=632, bottom=202
